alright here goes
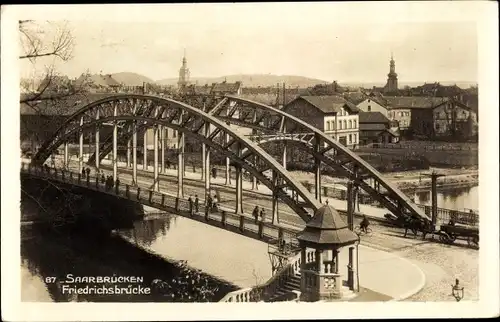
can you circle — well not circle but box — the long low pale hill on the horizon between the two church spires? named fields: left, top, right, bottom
left=157, top=74, right=331, bottom=88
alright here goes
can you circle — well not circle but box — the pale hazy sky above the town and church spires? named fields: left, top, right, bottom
left=17, top=3, right=478, bottom=83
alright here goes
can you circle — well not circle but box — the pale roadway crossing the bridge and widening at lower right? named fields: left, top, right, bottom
left=39, top=156, right=479, bottom=301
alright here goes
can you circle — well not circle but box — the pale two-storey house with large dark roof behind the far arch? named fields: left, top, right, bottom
left=283, top=95, right=359, bottom=147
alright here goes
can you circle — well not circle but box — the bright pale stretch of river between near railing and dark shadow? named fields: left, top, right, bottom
left=118, top=215, right=271, bottom=287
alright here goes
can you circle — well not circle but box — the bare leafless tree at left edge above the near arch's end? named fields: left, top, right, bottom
left=19, top=20, right=94, bottom=155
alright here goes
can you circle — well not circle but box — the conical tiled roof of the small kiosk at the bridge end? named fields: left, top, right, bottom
left=297, top=205, right=359, bottom=247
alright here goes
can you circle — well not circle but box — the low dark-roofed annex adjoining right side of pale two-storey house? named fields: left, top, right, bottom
left=359, top=112, right=399, bottom=145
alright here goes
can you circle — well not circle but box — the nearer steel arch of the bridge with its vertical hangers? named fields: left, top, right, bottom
left=32, top=94, right=321, bottom=221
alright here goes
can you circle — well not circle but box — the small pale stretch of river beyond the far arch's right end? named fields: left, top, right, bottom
left=415, top=186, right=479, bottom=211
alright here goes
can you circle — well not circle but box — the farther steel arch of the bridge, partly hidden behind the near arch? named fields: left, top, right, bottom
left=208, top=95, right=429, bottom=220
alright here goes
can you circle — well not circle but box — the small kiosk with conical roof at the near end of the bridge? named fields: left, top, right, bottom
left=297, top=205, right=359, bottom=302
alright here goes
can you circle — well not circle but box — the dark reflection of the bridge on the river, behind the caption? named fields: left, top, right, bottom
left=21, top=209, right=237, bottom=302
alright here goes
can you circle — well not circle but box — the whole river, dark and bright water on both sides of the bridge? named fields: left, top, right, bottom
left=21, top=187, right=478, bottom=302
